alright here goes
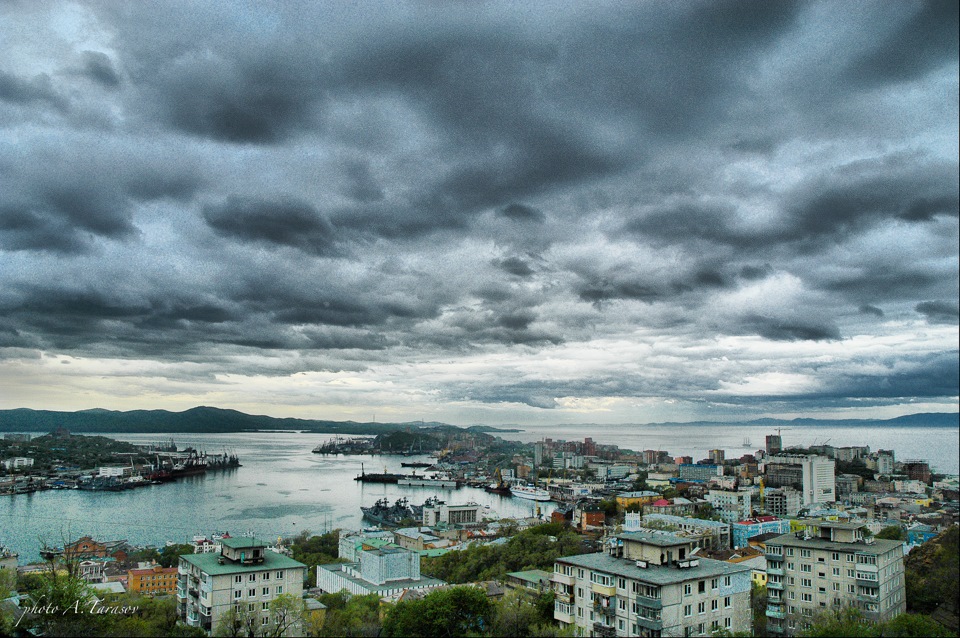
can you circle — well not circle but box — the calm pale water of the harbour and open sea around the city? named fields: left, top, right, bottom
left=0, top=425, right=960, bottom=563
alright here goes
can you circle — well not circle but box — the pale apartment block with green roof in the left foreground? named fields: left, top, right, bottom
left=177, top=538, right=307, bottom=635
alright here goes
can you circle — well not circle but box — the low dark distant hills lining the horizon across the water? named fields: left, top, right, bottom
left=0, top=406, right=960, bottom=434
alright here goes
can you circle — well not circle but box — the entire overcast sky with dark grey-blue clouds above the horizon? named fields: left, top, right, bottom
left=0, top=0, right=960, bottom=424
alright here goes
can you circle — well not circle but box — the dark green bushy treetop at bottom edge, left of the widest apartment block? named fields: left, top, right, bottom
left=383, top=587, right=493, bottom=638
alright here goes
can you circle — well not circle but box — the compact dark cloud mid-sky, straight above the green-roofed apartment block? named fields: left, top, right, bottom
left=203, top=195, right=336, bottom=255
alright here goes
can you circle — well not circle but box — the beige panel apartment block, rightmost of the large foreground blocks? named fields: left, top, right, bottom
left=766, top=521, right=906, bottom=635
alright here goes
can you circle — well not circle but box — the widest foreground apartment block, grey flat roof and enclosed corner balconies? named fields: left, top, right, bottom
left=551, top=532, right=750, bottom=637
